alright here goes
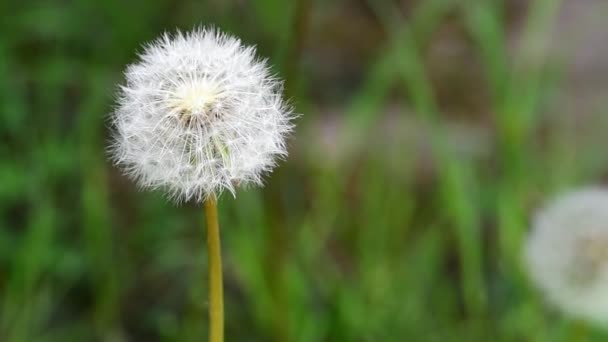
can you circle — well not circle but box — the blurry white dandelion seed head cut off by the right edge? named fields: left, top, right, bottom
left=525, top=188, right=608, bottom=325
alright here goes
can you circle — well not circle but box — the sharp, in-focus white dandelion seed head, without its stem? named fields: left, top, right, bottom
left=110, top=28, right=293, bottom=201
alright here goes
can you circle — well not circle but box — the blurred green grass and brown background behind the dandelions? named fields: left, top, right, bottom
left=0, top=0, right=608, bottom=342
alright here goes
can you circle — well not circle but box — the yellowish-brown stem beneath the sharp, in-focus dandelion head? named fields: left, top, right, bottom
left=205, top=197, right=224, bottom=342
